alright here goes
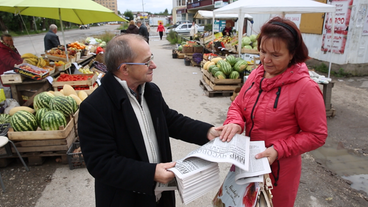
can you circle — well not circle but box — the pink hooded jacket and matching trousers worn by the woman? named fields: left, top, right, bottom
left=224, top=63, right=327, bottom=207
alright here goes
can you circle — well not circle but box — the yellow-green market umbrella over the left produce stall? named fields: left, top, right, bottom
left=0, top=0, right=128, bottom=63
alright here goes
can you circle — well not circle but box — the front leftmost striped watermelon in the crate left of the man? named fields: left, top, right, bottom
left=10, top=110, right=38, bottom=132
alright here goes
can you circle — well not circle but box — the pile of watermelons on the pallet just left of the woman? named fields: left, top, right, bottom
left=203, top=55, right=248, bottom=79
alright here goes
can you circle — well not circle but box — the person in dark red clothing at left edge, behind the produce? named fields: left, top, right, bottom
left=0, top=34, right=23, bottom=98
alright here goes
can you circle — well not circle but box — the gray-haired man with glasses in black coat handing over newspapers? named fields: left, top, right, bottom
left=78, top=34, right=220, bottom=207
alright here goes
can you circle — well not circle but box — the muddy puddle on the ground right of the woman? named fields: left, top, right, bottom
left=311, top=147, right=368, bottom=194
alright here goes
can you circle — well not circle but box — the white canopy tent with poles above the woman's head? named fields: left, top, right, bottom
left=212, top=0, right=336, bottom=77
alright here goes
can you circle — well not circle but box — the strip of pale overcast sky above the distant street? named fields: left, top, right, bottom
left=118, top=0, right=172, bottom=13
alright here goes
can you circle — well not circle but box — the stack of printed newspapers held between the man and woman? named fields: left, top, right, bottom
left=160, top=134, right=271, bottom=205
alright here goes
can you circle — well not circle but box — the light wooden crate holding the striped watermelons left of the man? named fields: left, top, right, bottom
left=8, top=118, right=74, bottom=141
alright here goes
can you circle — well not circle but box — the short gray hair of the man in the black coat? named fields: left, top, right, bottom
left=104, top=34, right=146, bottom=73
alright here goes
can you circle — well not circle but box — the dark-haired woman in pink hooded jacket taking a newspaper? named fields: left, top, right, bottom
left=220, top=17, right=327, bottom=207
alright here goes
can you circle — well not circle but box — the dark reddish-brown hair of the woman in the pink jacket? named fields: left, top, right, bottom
left=257, top=17, right=309, bottom=67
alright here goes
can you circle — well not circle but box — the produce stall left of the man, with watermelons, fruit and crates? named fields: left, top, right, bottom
left=0, top=37, right=106, bottom=169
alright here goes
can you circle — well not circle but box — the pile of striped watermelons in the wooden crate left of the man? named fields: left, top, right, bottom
left=10, top=92, right=78, bottom=132
